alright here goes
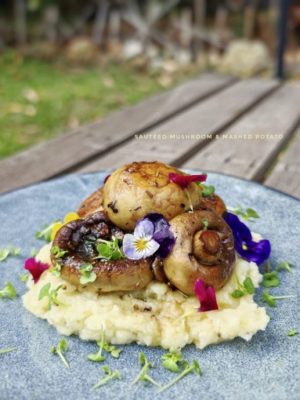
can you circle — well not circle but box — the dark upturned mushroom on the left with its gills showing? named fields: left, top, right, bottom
left=51, top=212, right=153, bottom=292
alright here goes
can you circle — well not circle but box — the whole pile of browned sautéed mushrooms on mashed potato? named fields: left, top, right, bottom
left=52, top=162, right=235, bottom=295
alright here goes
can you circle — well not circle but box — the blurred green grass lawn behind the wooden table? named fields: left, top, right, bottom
left=0, top=50, right=195, bottom=158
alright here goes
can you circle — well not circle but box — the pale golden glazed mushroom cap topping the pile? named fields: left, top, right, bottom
left=103, top=162, right=201, bottom=231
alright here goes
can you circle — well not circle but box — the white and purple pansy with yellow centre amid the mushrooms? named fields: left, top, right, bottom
left=123, top=213, right=175, bottom=260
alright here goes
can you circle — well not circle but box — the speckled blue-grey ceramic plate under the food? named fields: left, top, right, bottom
left=0, top=172, right=300, bottom=400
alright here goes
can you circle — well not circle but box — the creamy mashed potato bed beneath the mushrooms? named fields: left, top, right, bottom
left=23, top=241, right=269, bottom=350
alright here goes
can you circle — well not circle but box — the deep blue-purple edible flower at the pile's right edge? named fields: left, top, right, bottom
left=224, top=212, right=271, bottom=265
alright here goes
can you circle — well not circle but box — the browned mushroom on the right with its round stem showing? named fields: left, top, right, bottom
left=164, top=210, right=235, bottom=294
